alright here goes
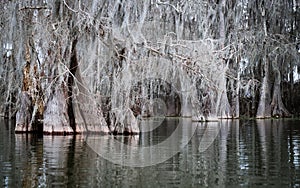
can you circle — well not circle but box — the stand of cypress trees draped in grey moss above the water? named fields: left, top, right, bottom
left=0, top=0, right=300, bottom=134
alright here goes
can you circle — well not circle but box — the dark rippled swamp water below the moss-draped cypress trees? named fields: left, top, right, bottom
left=0, top=118, right=300, bottom=187
